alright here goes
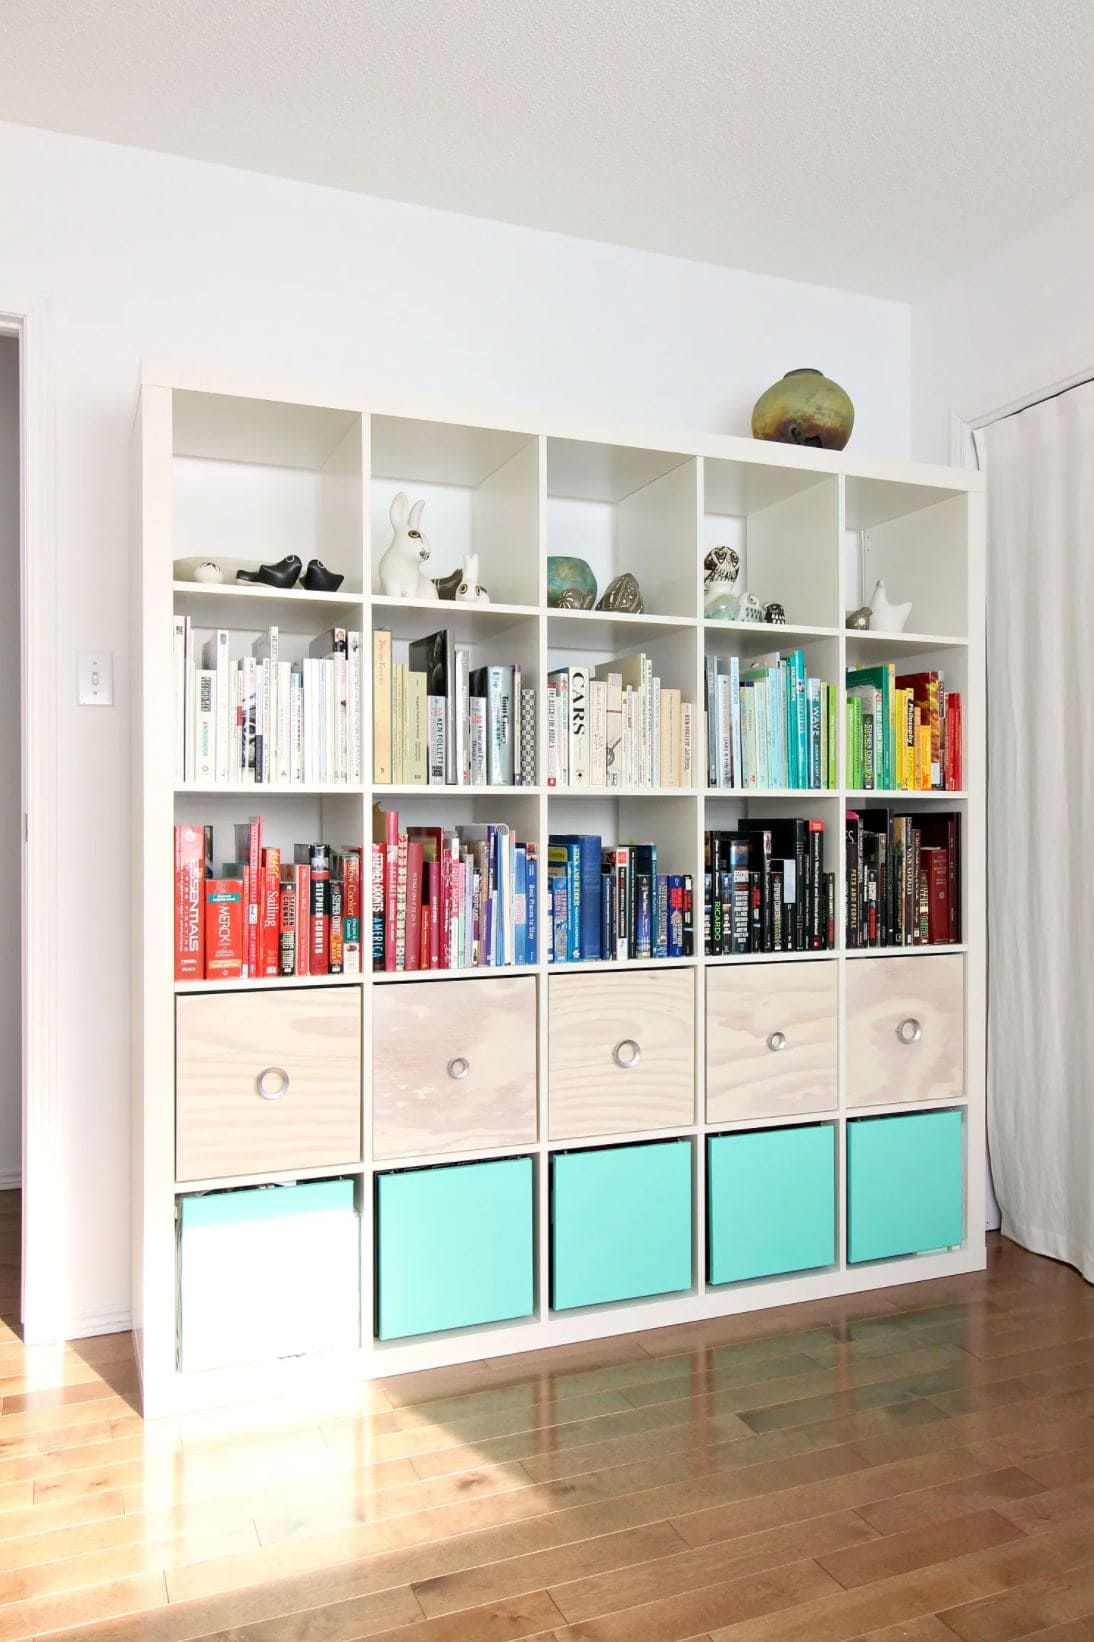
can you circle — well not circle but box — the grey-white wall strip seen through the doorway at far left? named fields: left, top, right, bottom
left=0, top=337, right=23, bottom=1187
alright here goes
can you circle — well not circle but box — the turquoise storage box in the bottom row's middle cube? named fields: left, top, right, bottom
left=550, top=1140, right=693, bottom=1310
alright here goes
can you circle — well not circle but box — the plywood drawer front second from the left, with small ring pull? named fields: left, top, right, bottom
left=373, top=977, right=536, bottom=1158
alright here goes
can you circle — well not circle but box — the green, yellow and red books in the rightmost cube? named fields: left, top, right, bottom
left=844, top=662, right=963, bottom=793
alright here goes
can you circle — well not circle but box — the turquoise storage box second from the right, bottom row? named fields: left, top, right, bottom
left=706, top=1123, right=836, bottom=1282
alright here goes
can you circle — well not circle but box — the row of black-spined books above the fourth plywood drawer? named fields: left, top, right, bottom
left=703, top=816, right=836, bottom=957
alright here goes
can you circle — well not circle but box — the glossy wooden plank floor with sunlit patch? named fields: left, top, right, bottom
left=0, top=1194, right=1094, bottom=1642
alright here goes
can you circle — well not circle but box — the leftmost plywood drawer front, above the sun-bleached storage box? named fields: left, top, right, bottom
left=176, top=987, right=361, bottom=1181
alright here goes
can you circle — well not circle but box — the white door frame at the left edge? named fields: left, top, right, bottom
left=0, top=286, right=66, bottom=1345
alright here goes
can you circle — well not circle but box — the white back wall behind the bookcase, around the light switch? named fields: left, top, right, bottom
left=0, top=125, right=910, bottom=1332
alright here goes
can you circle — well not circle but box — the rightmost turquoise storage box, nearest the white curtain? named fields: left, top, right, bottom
left=848, top=1112, right=964, bottom=1263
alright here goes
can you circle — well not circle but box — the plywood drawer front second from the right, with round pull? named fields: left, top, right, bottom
left=706, top=962, right=838, bottom=1123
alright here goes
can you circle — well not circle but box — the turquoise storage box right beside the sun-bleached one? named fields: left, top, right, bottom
left=376, top=1158, right=536, bottom=1340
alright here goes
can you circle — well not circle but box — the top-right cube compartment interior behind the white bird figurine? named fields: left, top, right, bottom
left=844, top=476, right=969, bottom=639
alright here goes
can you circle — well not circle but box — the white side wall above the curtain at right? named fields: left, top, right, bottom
left=912, top=194, right=1094, bottom=461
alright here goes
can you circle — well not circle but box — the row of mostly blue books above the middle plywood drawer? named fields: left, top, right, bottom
left=547, top=832, right=695, bottom=964
